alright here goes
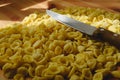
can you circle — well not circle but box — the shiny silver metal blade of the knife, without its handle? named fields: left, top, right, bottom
left=46, top=10, right=97, bottom=36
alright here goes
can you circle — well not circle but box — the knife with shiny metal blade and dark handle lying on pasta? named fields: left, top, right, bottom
left=46, top=10, right=120, bottom=48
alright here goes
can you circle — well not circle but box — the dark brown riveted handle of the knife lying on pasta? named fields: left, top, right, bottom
left=93, top=28, right=120, bottom=49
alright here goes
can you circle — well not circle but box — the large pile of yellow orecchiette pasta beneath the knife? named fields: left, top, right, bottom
left=0, top=7, right=120, bottom=80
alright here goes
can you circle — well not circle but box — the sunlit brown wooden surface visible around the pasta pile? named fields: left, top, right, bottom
left=0, top=0, right=120, bottom=80
